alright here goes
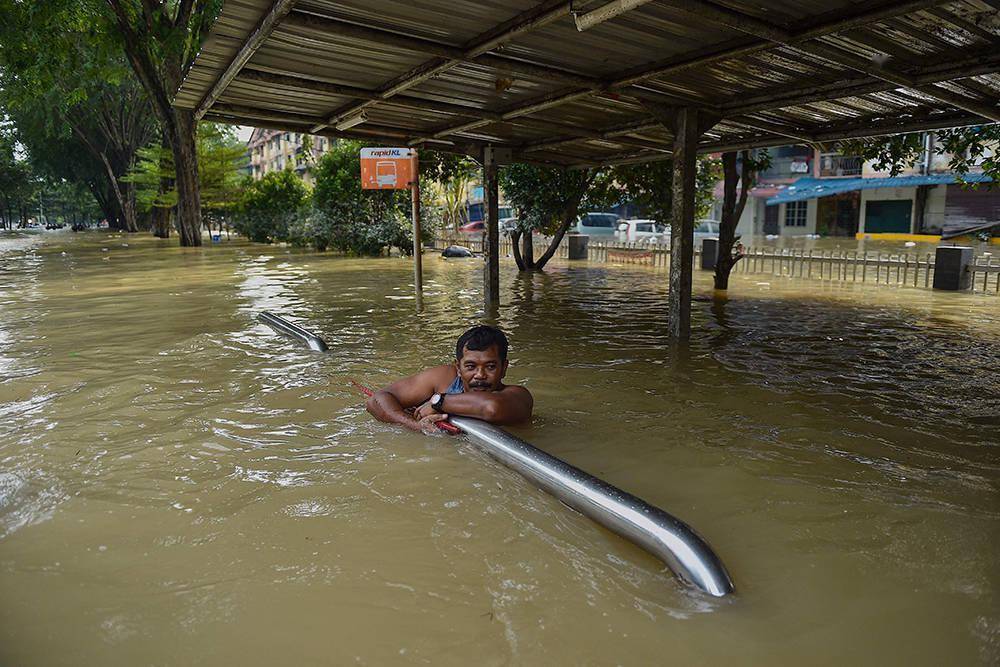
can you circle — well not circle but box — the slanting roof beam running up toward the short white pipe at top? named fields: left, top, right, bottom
left=304, top=0, right=572, bottom=132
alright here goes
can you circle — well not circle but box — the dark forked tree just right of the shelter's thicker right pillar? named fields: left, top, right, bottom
left=715, top=150, right=771, bottom=290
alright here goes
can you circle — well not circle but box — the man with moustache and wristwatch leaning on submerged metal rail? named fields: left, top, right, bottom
left=366, top=326, right=534, bottom=433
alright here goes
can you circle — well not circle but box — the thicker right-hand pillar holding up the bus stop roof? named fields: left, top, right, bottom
left=667, top=107, right=702, bottom=341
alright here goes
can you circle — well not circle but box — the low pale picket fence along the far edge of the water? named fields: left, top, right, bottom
left=435, top=236, right=1000, bottom=293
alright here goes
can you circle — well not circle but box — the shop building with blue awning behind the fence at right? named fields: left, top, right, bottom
left=728, top=133, right=1000, bottom=241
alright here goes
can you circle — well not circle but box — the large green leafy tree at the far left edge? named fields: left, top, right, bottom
left=0, top=0, right=155, bottom=231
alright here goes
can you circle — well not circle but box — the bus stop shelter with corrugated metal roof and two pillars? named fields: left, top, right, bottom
left=174, top=0, right=1000, bottom=339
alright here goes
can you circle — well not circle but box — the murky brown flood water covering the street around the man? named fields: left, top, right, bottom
left=0, top=232, right=1000, bottom=666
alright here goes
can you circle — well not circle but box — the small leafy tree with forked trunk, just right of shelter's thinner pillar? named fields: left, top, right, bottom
left=499, top=164, right=616, bottom=271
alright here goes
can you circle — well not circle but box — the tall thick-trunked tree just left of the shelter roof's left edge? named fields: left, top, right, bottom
left=107, top=0, right=220, bottom=246
